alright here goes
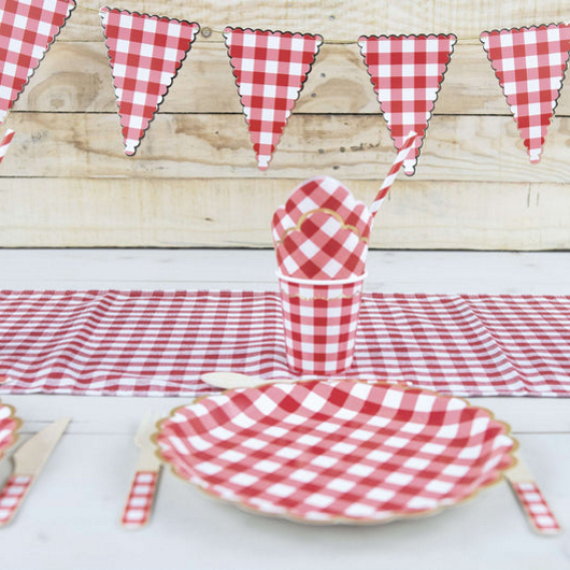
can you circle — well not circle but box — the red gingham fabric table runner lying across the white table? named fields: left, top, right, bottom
left=0, top=291, right=570, bottom=397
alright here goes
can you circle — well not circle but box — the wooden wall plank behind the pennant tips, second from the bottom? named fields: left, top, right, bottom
left=0, top=113, right=570, bottom=181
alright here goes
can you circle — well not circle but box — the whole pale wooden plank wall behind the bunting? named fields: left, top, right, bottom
left=0, top=0, right=570, bottom=250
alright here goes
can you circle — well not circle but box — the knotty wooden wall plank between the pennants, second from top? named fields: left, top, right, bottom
left=14, top=42, right=570, bottom=116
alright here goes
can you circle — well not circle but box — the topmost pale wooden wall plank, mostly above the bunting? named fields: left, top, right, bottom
left=51, top=0, right=569, bottom=41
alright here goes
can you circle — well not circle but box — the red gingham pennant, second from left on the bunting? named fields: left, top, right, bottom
left=100, top=7, right=200, bottom=156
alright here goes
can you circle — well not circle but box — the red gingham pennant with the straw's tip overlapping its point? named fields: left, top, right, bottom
left=358, top=34, right=457, bottom=175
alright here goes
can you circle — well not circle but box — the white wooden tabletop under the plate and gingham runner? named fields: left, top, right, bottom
left=0, top=250, right=570, bottom=570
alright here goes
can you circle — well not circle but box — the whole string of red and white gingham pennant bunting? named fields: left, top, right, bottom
left=0, top=0, right=570, bottom=170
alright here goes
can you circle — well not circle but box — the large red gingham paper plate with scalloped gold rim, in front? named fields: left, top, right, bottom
left=157, top=381, right=514, bottom=523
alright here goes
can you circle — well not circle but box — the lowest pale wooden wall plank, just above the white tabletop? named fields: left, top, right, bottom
left=0, top=178, right=570, bottom=250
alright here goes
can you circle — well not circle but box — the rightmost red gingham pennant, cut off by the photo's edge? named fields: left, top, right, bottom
left=481, top=24, right=570, bottom=162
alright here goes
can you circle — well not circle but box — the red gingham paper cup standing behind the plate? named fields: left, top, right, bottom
left=276, top=271, right=367, bottom=374
